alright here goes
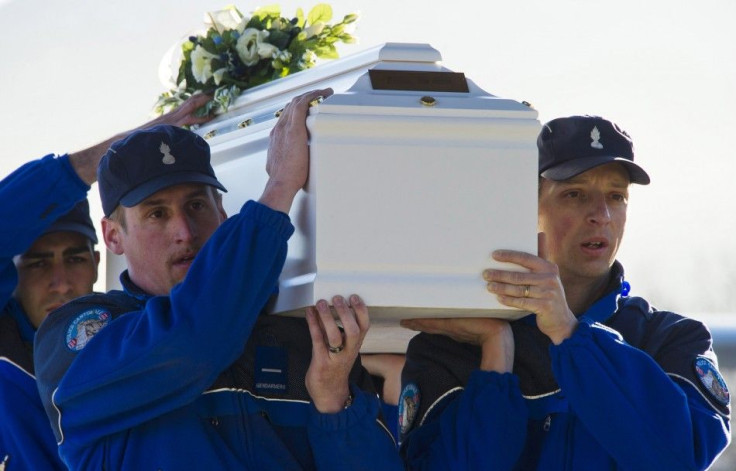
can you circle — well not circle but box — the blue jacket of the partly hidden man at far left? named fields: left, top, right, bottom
left=0, top=155, right=89, bottom=471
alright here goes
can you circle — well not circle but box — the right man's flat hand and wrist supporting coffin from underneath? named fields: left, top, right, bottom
left=401, top=317, right=514, bottom=373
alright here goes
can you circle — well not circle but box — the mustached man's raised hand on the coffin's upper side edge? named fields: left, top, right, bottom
left=259, top=88, right=332, bottom=214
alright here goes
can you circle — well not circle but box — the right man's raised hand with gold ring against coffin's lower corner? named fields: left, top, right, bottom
left=483, top=234, right=577, bottom=345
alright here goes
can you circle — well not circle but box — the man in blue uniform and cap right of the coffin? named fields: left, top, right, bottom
left=400, top=116, right=730, bottom=471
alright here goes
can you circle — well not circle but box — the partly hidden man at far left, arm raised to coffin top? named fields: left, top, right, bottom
left=0, top=95, right=211, bottom=470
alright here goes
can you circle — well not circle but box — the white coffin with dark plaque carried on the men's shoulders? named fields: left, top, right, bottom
left=105, top=44, right=540, bottom=352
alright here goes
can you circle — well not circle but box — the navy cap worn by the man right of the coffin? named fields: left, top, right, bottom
left=537, top=115, right=649, bottom=185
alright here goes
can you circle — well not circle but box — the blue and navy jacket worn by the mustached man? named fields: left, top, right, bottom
left=35, top=202, right=402, bottom=471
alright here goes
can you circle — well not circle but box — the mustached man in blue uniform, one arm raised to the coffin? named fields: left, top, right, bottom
left=35, top=90, right=403, bottom=470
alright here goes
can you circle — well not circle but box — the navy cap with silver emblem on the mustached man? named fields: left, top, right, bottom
left=97, top=125, right=227, bottom=217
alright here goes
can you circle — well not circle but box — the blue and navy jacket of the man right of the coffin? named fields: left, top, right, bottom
left=399, top=263, right=730, bottom=471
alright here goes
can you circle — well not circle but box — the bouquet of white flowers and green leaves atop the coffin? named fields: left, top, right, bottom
left=154, top=3, right=358, bottom=115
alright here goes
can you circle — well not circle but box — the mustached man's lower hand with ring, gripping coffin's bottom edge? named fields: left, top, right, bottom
left=305, top=295, right=370, bottom=414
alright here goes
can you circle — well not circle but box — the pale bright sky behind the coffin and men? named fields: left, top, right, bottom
left=0, top=0, right=736, bottom=325
